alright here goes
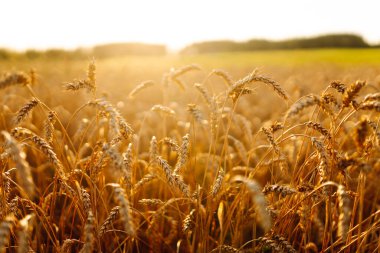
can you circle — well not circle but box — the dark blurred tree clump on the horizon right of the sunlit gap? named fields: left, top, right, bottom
left=181, top=34, right=370, bottom=54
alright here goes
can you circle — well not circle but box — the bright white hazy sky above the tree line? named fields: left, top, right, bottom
left=0, top=0, right=380, bottom=49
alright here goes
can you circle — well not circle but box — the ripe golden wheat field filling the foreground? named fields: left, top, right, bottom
left=0, top=54, right=380, bottom=252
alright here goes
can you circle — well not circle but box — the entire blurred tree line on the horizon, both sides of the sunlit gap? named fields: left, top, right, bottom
left=0, top=34, right=380, bottom=60
